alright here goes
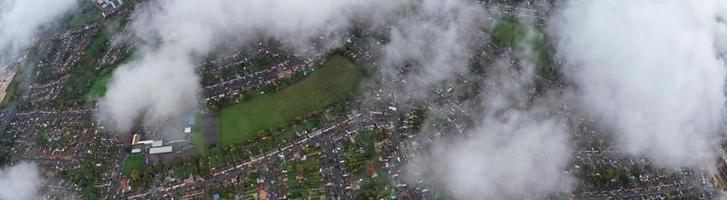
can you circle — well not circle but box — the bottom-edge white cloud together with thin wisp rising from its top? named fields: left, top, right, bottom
left=409, top=52, right=573, bottom=199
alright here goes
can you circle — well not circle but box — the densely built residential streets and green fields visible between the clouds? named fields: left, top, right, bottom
left=0, top=0, right=727, bottom=199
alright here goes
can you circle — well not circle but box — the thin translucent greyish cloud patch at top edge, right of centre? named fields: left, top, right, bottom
left=381, top=0, right=489, bottom=96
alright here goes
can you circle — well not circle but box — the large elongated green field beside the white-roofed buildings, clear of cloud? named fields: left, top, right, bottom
left=219, top=56, right=363, bottom=146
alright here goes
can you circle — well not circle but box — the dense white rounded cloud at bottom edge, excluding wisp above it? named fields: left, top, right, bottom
left=410, top=110, right=572, bottom=199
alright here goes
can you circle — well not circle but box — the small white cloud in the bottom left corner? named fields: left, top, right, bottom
left=0, top=162, right=43, bottom=199
